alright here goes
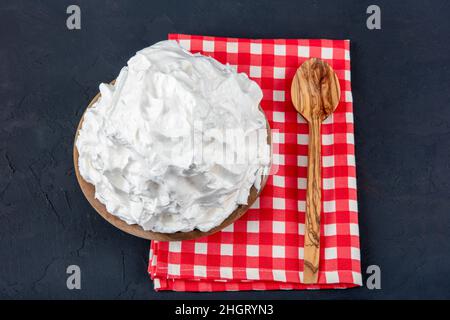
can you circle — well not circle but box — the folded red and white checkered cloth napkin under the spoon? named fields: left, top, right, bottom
left=148, top=34, right=361, bottom=291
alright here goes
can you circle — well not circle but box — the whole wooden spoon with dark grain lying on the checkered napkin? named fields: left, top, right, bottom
left=291, top=58, right=340, bottom=283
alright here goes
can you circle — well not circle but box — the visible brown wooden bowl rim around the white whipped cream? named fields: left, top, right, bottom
left=73, top=85, right=272, bottom=241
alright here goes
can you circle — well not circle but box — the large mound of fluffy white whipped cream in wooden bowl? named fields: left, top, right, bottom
left=76, top=41, right=270, bottom=233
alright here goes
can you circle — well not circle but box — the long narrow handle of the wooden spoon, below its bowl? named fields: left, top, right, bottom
left=303, top=117, right=322, bottom=283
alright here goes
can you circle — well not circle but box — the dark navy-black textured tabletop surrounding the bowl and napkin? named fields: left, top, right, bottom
left=0, top=0, right=450, bottom=299
